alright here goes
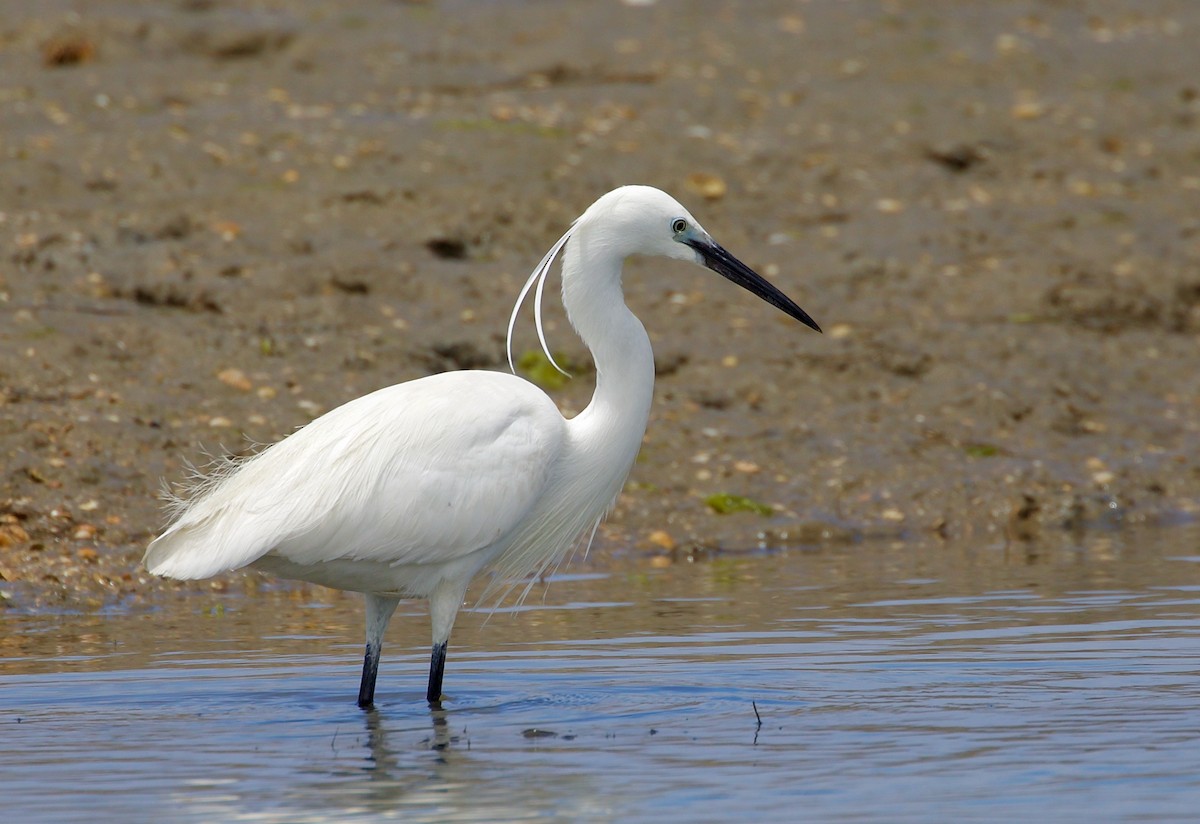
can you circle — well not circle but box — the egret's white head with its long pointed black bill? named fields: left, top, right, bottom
left=576, top=186, right=821, bottom=332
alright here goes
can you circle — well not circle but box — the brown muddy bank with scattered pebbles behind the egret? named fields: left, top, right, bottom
left=0, top=0, right=1200, bottom=605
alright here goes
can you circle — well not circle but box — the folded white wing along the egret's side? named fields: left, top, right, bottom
left=144, top=372, right=565, bottom=578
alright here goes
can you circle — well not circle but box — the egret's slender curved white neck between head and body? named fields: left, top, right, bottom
left=563, top=233, right=654, bottom=438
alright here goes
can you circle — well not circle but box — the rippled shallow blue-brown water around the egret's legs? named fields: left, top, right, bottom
left=0, top=527, right=1200, bottom=822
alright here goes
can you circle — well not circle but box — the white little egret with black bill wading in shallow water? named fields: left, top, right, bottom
left=143, top=186, right=821, bottom=708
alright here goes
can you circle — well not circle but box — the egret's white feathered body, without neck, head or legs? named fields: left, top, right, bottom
left=146, top=371, right=648, bottom=597
